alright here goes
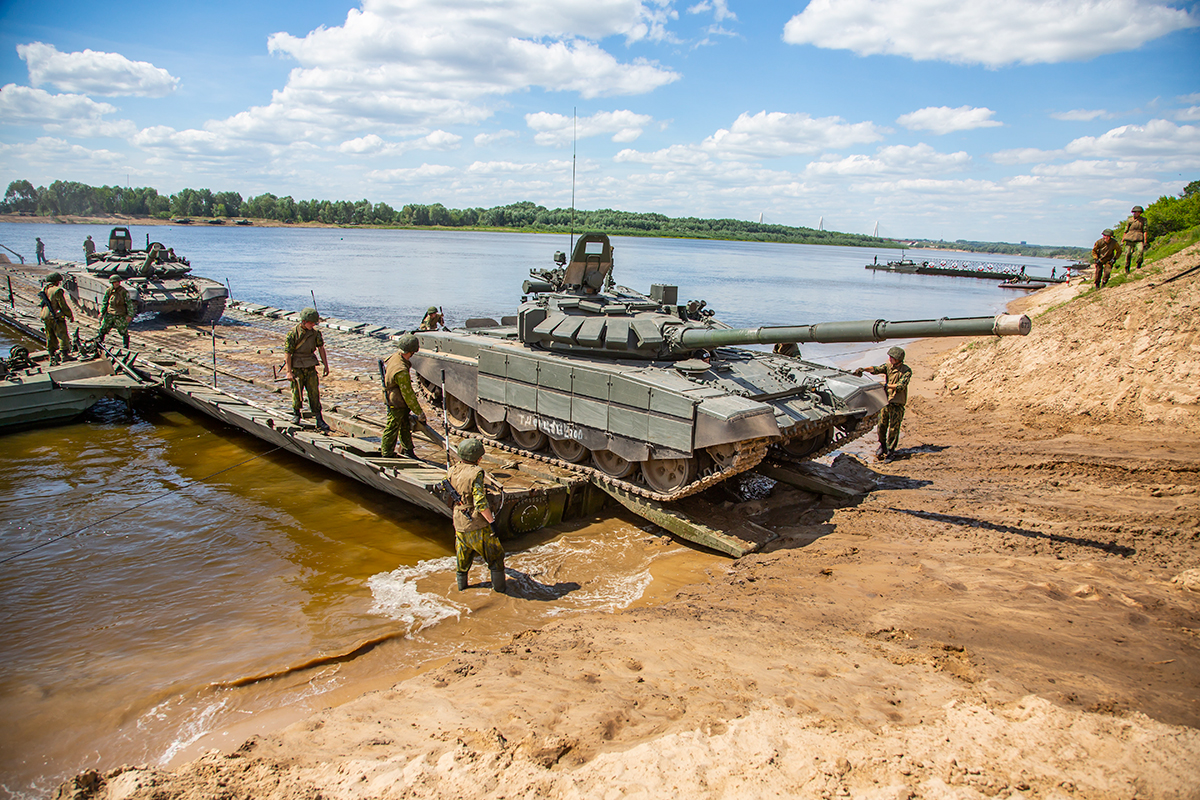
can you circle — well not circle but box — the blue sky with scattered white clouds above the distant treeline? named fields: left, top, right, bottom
left=0, top=0, right=1200, bottom=246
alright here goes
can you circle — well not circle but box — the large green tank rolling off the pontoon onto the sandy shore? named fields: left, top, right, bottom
left=413, top=234, right=1030, bottom=501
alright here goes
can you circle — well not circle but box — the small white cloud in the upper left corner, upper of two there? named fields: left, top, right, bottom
left=17, top=42, right=179, bottom=97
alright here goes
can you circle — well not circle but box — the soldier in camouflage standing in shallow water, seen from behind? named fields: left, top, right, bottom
left=446, top=439, right=505, bottom=594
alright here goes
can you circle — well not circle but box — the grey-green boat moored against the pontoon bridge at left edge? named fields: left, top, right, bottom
left=0, top=347, right=152, bottom=431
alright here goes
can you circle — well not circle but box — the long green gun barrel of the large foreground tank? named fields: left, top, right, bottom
left=679, top=314, right=1032, bottom=349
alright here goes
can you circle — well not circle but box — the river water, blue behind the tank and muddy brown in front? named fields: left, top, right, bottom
left=0, top=223, right=1062, bottom=798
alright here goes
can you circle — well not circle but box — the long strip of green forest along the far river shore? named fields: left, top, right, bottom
left=0, top=180, right=1086, bottom=258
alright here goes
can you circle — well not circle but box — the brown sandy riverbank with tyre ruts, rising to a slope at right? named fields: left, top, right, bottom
left=60, top=247, right=1200, bottom=800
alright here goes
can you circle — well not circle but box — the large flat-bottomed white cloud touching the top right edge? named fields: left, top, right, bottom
left=784, top=0, right=1200, bottom=68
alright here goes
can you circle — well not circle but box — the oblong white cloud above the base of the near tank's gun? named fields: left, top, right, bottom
left=701, top=112, right=886, bottom=160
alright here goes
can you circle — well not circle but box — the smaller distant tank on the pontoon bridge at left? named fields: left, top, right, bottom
left=62, top=228, right=229, bottom=323
